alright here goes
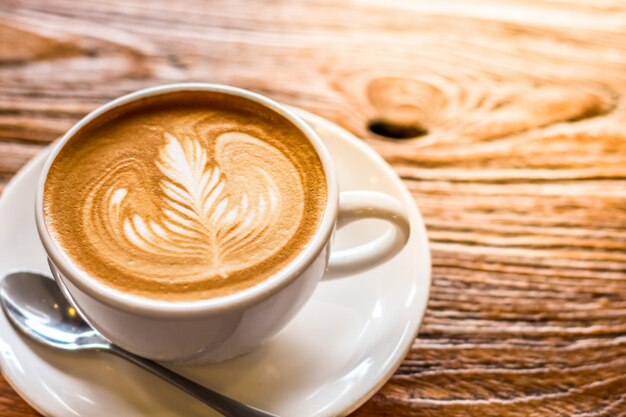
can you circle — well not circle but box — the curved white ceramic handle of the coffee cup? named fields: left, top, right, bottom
left=323, top=191, right=411, bottom=280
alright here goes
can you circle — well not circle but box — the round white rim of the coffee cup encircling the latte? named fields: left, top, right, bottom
left=35, top=83, right=339, bottom=317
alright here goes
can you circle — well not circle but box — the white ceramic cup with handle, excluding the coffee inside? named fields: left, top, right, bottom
left=35, top=83, right=410, bottom=363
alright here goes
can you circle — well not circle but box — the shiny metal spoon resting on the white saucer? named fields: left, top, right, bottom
left=0, top=272, right=277, bottom=417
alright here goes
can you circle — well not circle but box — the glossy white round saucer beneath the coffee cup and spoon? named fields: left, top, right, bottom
left=0, top=111, right=430, bottom=417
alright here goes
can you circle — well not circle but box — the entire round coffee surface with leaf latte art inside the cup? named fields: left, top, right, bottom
left=44, top=92, right=327, bottom=301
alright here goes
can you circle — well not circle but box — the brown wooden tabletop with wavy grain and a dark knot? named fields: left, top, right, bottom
left=0, top=0, right=626, bottom=417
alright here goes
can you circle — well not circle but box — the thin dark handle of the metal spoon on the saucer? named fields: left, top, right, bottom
left=109, top=345, right=278, bottom=417
